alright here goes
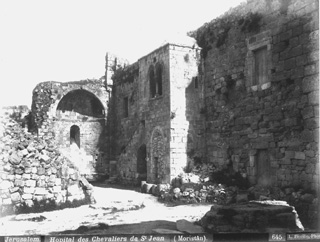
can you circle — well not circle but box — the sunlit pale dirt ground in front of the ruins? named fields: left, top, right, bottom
left=0, top=184, right=215, bottom=236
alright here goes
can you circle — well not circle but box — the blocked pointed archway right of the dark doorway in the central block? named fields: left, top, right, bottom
left=148, top=128, right=166, bottom=184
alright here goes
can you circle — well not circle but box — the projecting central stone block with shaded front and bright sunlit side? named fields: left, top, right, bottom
left=111, top=44, right=203, bottom=183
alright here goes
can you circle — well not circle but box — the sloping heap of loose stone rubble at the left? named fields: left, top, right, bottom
left=0, top=108, right=92, bottom=214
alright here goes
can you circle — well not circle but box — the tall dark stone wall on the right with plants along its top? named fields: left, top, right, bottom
left=192, top=0, right=320, bottom=190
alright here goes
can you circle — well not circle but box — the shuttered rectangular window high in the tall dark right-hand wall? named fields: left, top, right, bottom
left=252, top=46, right=268, bottom=85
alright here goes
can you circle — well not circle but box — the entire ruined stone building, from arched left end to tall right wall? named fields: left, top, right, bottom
left=33, top=0, right=320, bottom=192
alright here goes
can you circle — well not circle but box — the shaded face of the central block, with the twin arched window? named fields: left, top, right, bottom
left=113, top=46, right=170, bottom=182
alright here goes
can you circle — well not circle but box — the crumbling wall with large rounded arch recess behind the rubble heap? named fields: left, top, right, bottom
left=32, top=79, right=110, bottom=179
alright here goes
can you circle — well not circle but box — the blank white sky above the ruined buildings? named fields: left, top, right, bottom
left=0, top=0, right=245, bottom=107
